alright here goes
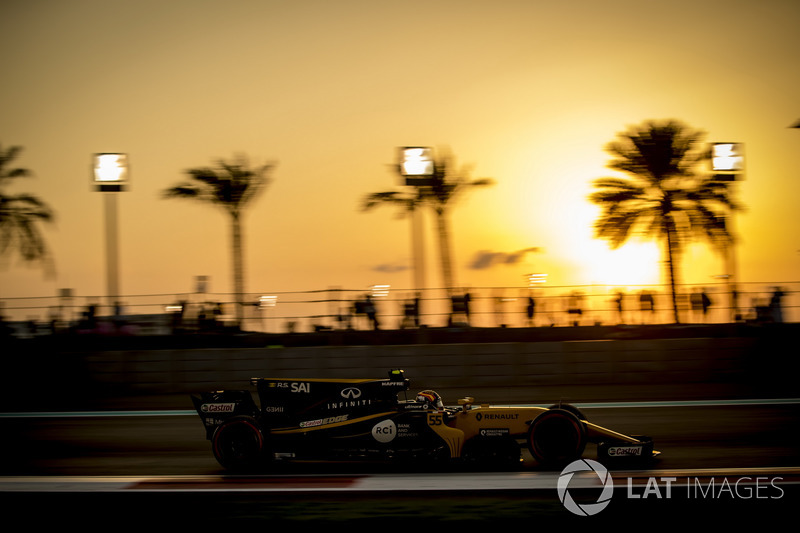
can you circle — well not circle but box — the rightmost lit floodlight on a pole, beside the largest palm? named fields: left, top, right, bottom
left=711, top=142, right=744, bottom=321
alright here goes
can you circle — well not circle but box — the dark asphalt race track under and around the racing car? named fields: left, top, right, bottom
left=0, top=399, right=800, bottom=527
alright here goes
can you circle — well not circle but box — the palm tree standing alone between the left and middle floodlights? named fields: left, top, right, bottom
left=164, top=156, right=273, bottom=326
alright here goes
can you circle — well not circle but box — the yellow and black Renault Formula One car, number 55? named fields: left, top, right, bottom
left=192, top=370, right=658, bottom=472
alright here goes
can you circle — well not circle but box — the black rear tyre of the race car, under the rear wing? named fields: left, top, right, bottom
left=211, top=416, right=265, bottom=472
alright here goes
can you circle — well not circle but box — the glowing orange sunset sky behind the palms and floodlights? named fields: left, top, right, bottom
left=0, top=0, right=800, bottom=322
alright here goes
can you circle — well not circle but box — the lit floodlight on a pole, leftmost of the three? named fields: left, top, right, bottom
left=92, top=153, right=129, bottom=315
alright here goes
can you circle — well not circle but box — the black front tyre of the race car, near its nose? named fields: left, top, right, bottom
left=528, top=409, right=586, bottom=467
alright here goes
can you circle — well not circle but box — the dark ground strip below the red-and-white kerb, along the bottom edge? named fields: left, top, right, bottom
left=3, top=478, right=800, bottom=530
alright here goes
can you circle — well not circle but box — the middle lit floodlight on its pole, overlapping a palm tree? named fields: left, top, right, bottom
left=399, top=146, right=434, bottom=293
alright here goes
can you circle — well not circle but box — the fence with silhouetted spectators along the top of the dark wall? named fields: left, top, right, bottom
left=0, top=282, right=800, bottom=335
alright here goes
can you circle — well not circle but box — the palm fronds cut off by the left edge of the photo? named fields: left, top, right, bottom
left=0, top=146, right=53, bottom=270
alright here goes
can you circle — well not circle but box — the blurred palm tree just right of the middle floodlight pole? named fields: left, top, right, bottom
left=362, top=150, right=494, bottom=291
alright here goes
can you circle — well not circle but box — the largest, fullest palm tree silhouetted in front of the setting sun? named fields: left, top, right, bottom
left=590, top=120, right=740, bottom=323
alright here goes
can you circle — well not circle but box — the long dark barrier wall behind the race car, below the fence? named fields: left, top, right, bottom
left=4, top=320, right=797, bottom=409
